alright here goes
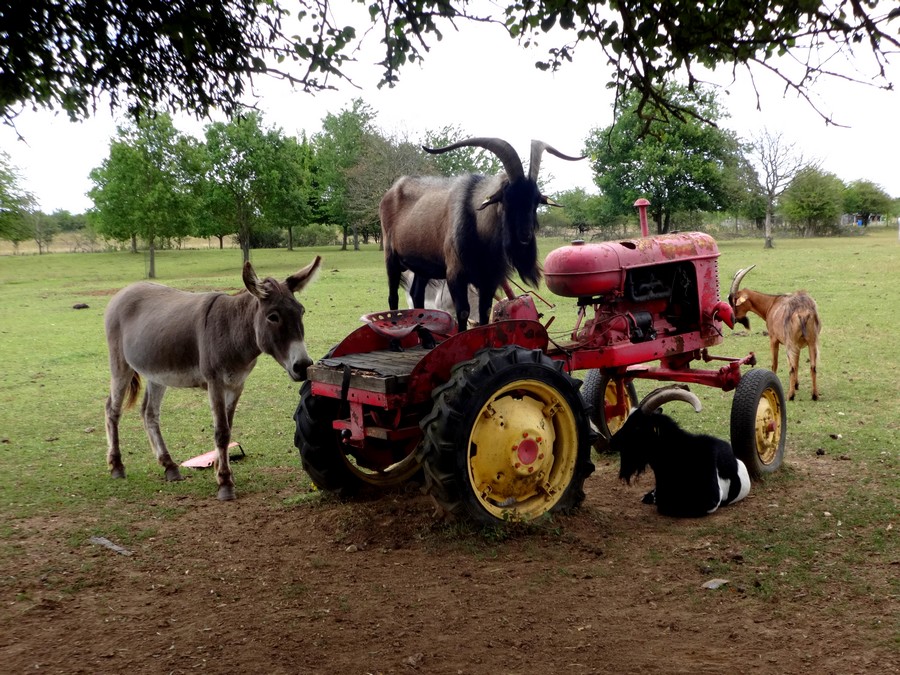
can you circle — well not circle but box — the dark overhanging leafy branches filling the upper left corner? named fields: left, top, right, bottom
left=0, top=0, right=355, bottom=121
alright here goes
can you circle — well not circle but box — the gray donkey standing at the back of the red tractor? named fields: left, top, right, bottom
left=106, top=256, right=322, bottom=501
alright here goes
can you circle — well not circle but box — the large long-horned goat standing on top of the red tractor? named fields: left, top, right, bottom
left=380, top=138, right=583, bottom=330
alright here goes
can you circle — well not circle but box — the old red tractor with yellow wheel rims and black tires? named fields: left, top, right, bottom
left=295, top=200, right=787, bottom=524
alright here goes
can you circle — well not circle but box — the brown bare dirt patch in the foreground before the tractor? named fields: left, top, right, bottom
left=0, top=458, right=900, bottom=675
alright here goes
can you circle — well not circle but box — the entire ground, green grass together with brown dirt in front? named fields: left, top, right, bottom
left=0, top=230, right=900, bottom=675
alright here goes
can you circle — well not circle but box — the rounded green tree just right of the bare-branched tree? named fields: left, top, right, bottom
left=779, top=166, right=845, bottom=236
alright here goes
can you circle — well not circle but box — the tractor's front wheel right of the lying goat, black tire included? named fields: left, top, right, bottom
left=731, top=368, right=787, bottom=479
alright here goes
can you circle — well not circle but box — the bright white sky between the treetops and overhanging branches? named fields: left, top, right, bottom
left=0, top=15, right=900, bottom=213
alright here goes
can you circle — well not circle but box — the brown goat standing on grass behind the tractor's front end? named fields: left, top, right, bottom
left=728, top=265, right=821, bottom=401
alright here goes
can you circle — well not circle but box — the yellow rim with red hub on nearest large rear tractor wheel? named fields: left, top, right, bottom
left=467, top=380, right=578, bottom=520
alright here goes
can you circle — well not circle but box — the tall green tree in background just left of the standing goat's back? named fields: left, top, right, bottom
left=312, top=98, right=378, bottom=250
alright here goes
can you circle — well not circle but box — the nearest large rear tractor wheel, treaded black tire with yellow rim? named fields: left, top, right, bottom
left=419, top=345, right=594, bottom=525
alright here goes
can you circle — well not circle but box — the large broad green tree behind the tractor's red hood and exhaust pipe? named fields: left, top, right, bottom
left=585, top=85, right=739, bottom=234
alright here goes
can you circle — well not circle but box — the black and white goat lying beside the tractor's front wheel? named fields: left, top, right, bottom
left=610, top=387, right=750, bottom=517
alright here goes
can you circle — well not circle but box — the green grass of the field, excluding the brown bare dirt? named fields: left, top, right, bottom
left=0, top=230, right=900, bottom=553
